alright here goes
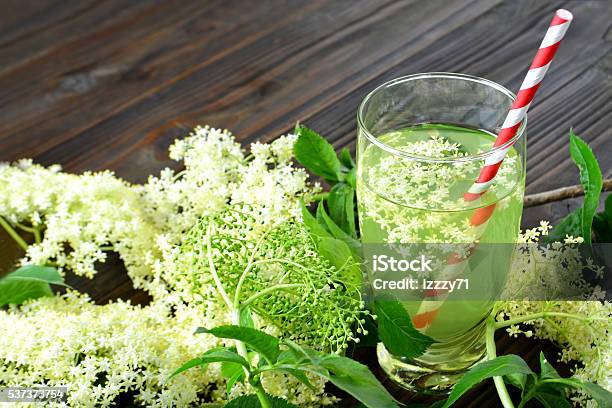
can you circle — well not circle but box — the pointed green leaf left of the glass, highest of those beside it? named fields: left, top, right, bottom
left=294, top=124, right=343, bottom=182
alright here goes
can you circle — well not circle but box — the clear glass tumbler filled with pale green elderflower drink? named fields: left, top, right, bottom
left=357, top=73, right=527, bottom=392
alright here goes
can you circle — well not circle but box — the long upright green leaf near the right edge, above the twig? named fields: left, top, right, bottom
left=570, top=130, right=603, bottom=244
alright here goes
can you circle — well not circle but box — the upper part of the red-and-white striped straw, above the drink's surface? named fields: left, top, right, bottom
left=464, top=9, right=574, bottom=201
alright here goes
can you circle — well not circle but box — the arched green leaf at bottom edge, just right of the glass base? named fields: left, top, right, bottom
left=444, top=354, right=533, bottom=408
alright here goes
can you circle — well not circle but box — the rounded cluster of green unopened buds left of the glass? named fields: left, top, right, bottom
left=175, top=205, right=367, bottom=352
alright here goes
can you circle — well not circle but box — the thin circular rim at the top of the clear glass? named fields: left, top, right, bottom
left=357, top=72, right=527, bottom=163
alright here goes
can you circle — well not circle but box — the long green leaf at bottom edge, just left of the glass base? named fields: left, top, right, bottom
left=317, top=354, right=398, bottom=408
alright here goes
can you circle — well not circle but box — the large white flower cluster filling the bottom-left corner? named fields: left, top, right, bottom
left=0, top=294, right=223, bottom=407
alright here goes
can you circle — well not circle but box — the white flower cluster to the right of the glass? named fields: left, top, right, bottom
left=496, top=225, right=612, bottom=406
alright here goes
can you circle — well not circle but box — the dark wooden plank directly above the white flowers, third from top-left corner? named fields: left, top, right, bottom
left=0, top=1, right=502, bottom=180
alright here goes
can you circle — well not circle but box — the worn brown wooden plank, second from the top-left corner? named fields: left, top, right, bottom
left=0, top=2, right=326, bottom=169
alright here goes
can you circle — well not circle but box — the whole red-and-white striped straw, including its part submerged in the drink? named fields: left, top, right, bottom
left=412, top=9, right=574, bottom=330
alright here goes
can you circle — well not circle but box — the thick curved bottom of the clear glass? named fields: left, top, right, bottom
left=376, top=319, right=486, bottom=395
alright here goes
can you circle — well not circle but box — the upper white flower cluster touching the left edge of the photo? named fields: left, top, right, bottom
left=0, top=160, right=155, bottom=287
